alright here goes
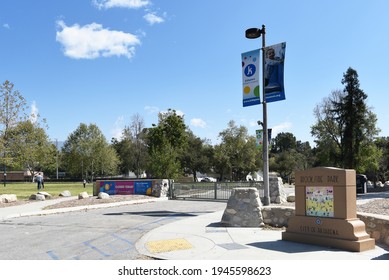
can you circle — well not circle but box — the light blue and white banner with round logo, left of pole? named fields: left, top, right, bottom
left=242, top=49, right=261, bottom=107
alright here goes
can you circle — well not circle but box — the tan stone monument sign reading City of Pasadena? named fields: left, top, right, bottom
left=282, top=167, right=375, bottom=252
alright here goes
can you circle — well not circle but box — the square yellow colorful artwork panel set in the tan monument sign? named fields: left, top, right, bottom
left=305, top=187, right=334, bottom=217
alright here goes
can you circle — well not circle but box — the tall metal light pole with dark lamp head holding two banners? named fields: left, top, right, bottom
left=246, top=25, right=270, bottom=205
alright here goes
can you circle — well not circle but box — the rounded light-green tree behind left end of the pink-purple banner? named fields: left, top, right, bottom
left=62, top=123, right=119, bottom=179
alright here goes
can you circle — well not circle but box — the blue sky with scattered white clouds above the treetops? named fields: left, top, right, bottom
left=0, top=0, right=389, bottom=147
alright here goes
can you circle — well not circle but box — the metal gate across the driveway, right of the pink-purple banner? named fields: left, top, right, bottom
left=170, top=181, right=264, bottom=200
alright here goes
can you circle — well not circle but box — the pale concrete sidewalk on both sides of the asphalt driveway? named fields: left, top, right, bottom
left=0, top=197, right=389, bottom=260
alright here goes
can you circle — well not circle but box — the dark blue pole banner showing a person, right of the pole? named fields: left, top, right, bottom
left=263, top=42, right=286, bottom=103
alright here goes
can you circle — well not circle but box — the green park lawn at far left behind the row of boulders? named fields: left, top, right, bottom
left=0, top=182, right=93, bottom=200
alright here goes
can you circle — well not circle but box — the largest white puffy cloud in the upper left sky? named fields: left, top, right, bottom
left=56, top=20, right=140, bottom=59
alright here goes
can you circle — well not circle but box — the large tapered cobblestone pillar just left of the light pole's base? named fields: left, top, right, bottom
left=221, top=188, right=264, bottom=227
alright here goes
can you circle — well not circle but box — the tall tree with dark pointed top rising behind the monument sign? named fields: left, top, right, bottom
left=311, top=68, right=379, bottom=172
